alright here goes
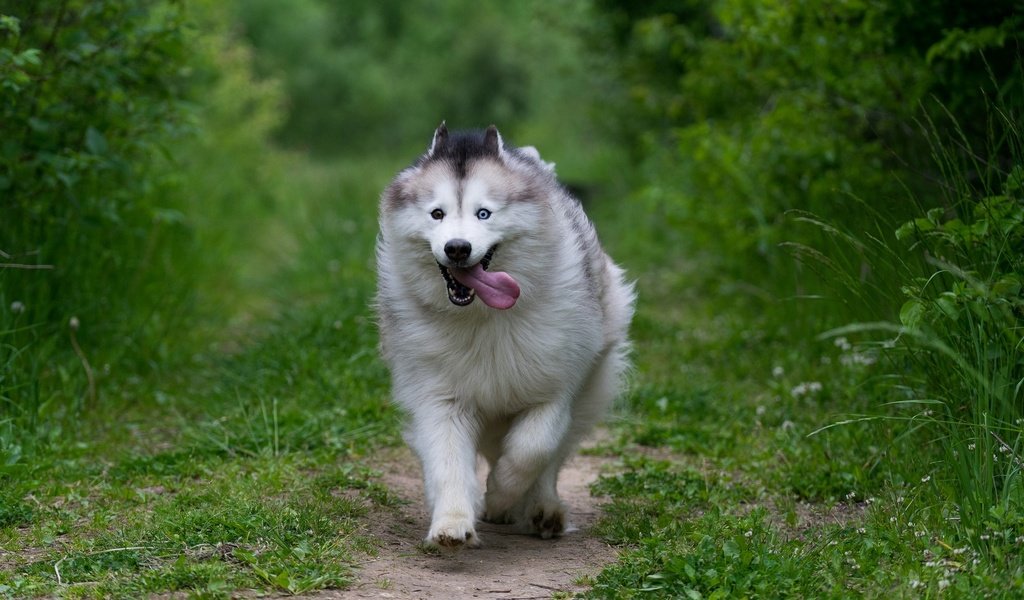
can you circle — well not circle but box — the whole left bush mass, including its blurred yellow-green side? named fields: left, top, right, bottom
left=0, top=0, right=288, bottom=448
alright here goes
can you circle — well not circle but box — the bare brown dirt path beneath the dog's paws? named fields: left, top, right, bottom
left=316, top=451, right=616, bottom=600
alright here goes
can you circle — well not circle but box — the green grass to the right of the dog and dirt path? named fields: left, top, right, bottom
left=586, top=180, right=1024, bottom=598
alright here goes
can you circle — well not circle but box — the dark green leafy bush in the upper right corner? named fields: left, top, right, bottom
left=598, top=0, right=1022, bottom=284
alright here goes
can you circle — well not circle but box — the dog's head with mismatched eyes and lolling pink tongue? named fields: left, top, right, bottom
left=381, top=123, right=554, bottom=308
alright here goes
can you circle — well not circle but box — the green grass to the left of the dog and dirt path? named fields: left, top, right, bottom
left=0, top=155, right=398, bottom=598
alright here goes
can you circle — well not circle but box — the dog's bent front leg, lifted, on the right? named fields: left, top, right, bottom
left=484, top=400, right=570, bottom=538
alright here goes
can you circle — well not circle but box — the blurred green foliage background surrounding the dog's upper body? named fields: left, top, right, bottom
left=0, top=0, right=1024, bottom=593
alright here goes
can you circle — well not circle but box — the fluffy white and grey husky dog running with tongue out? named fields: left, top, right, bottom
left=376, top=123, right=634, bottom=548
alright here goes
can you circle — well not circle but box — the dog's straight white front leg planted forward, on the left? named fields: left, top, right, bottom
left=410, top=400, right=480, bottom=549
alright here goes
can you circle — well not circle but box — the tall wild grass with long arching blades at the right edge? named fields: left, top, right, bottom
left=797, top=96, right=1024, bottom=547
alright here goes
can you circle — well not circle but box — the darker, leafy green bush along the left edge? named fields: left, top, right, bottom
left=0, top=0, right=188, bottom=434
